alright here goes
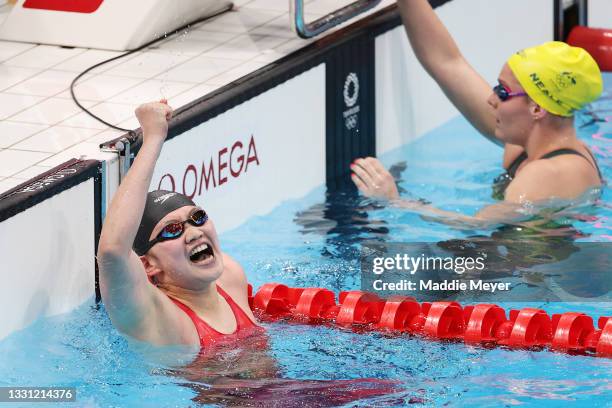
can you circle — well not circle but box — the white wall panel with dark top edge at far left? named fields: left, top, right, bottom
left=0, top=160, right=102, bottom=339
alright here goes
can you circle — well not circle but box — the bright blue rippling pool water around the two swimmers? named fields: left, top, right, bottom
left=0, top=74, right=612, bottom=407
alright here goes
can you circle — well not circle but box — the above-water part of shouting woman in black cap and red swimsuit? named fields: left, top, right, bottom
left=98, top=100, right=263, bottom=349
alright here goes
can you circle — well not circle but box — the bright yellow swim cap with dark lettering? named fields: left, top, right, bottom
left=508, top=41, right=603, bottom=116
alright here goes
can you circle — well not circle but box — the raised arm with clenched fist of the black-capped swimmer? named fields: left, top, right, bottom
left=97, top=103, right=172, bottom=334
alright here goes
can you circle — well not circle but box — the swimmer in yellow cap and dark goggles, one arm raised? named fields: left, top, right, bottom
left=351, top=0, right=603, bottom=226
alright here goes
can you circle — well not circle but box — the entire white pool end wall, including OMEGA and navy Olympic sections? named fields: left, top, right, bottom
left=0, top=0, right=564, bottom=338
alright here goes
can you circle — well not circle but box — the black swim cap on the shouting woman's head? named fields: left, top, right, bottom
left=132, top=190, right=195, bottom=256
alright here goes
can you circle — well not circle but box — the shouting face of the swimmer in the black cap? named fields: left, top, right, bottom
left=142, top=206, right=223, bottom=290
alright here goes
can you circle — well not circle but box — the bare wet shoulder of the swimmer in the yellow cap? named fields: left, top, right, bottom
left=504, top=155, right=598, bottom=203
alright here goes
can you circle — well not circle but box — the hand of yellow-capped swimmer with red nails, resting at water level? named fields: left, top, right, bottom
left=351, top=157, right=399, bottom=200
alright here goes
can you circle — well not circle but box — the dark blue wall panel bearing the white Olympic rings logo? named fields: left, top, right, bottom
left=325, top=37, right=376, bottom=191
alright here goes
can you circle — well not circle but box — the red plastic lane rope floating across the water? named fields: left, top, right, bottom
left=249, top=283, right=612, bottom=358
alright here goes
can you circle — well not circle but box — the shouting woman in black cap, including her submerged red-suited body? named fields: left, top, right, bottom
left=98, top=101, right=400, bottom=407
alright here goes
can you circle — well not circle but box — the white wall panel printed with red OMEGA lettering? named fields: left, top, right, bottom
left=150, top=64, right=325, bottom=232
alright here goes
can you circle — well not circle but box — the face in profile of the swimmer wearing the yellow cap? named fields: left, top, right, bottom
left=488, top=64, right=535, bottom=146
